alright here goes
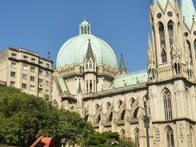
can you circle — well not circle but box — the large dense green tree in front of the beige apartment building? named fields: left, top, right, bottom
left=0, top=87, right=94, bottom=147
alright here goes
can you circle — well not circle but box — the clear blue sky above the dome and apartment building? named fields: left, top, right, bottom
left=0, top=0, right=194, bottom=72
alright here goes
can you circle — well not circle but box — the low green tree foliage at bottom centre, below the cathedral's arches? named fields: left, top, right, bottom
left=84, top=131, right=135, bottom=147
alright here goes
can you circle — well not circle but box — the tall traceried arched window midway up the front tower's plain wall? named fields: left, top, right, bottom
left=163, top=88, right=173, bottom=120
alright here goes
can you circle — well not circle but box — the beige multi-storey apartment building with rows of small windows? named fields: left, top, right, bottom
left=0, top=47, right=53, bottom=99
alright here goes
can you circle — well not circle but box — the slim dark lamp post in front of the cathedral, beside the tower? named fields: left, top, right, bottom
left=143, top=96, right=150, bottom=147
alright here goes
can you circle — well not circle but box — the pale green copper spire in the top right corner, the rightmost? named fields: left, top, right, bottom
left=181, top=0, right=195, bottom=29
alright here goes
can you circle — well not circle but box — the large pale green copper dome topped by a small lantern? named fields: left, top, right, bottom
left=56, top=21, right=117, bottom=68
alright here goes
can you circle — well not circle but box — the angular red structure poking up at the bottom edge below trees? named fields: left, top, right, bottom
left=30, top=136, right=55, bottom=147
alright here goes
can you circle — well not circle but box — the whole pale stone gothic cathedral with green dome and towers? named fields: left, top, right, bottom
left=52, top=0, right=196, bottom=147
